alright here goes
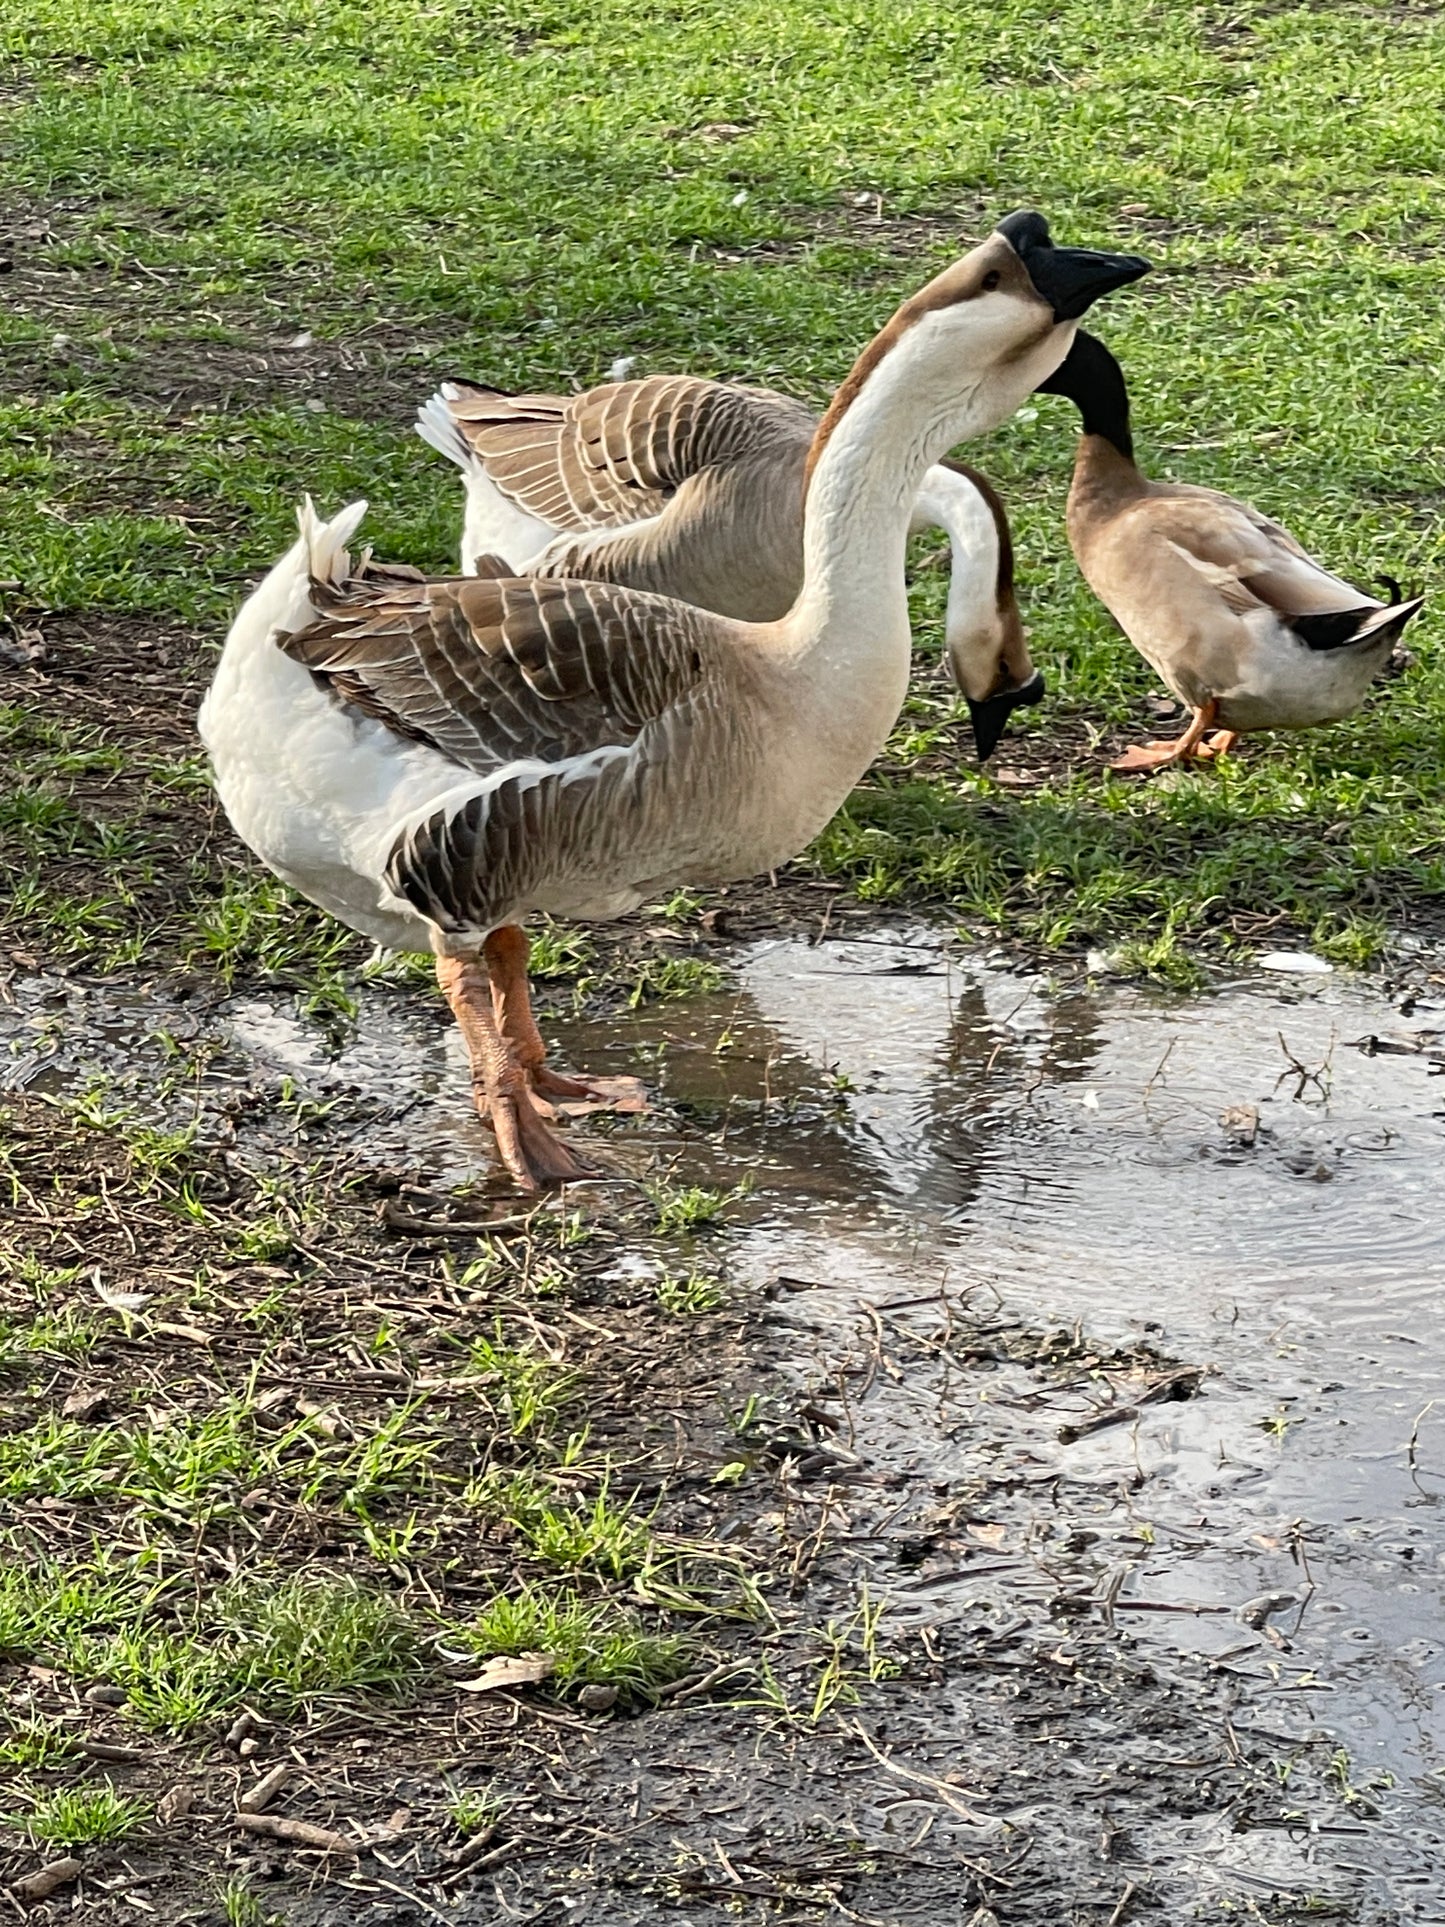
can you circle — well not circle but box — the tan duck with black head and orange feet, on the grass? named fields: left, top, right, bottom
left=1040, top=330, right=1422, bottom=771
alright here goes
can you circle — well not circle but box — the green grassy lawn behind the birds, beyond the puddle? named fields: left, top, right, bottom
left=0, top=0, right=1445, bottom=963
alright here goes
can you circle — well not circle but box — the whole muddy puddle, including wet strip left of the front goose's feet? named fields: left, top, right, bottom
left=6, top=933, right=1445, bottom=1921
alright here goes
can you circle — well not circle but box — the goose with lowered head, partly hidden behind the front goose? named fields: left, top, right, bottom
left=416, top=374, right=1044, bottom=761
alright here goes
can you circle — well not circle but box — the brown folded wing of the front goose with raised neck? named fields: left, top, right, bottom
left=277, top=570, right=723, bottom=777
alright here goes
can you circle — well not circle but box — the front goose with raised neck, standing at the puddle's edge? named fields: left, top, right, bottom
left=200, top=214, right=1146, bottom=1189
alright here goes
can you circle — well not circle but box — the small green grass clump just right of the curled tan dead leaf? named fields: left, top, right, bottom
left=466, top=1586, right=690, bottom=1700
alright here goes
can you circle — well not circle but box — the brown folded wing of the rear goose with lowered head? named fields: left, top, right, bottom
left=441, top=376, right=815, bottom=530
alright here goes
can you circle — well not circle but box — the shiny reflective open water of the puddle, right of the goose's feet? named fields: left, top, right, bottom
left=568, top=938, right=1445, bottom=1896
